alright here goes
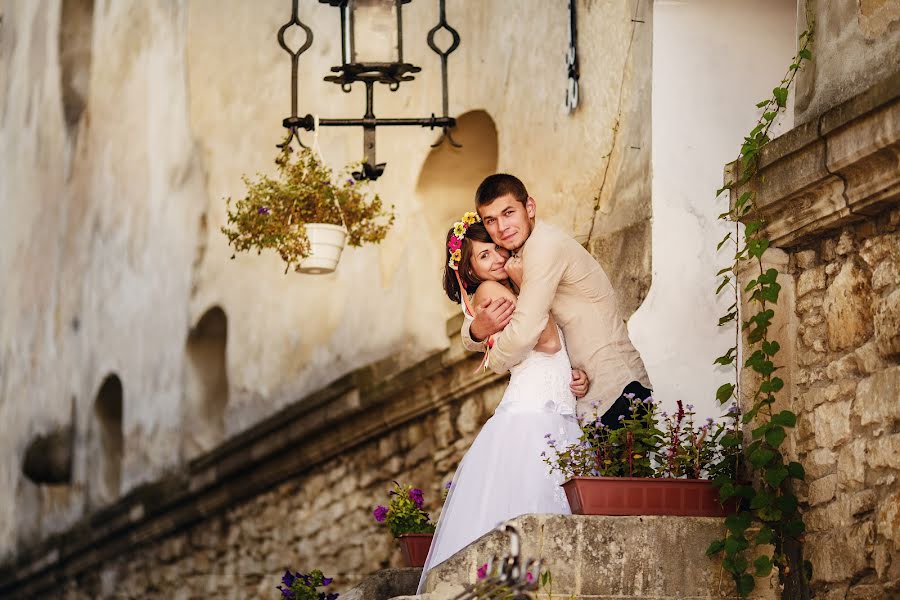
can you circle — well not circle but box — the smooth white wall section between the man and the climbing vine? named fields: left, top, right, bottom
left=628, top=0, right=795, bottom=417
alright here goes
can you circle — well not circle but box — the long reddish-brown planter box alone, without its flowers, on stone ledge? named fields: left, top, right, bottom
left=562, top=477, right=733, bottom=517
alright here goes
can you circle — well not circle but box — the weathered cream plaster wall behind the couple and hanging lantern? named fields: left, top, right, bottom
left=0, top=0, right=650, bottom=555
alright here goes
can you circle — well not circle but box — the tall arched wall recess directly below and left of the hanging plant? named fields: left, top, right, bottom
left=182, top=306, right=228, bottom=459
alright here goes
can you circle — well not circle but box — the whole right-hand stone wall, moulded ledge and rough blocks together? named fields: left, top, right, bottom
left=726, top=74, right=900, bottom=600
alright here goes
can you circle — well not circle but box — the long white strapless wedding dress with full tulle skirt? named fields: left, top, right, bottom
left=416, top=327, right=581, bottom=594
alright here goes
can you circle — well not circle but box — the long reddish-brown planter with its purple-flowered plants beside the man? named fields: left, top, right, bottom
left=544, top=398, right=741, bottom=516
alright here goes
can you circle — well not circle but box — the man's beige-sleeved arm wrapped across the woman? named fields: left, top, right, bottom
left=488, top=238, right=567, bottom=373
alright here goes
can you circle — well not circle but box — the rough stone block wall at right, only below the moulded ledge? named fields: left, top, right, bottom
left=789, top=208, right=900, bottom=600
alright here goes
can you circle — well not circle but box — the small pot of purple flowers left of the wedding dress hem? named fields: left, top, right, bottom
left=372, top=481, right=434, bottom=567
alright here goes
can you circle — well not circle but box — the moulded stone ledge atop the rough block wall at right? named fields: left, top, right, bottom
left=725, top=73, right=900, bottom=248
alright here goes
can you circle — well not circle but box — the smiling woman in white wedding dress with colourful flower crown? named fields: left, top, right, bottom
left=417, top=212, right=588, bottom=594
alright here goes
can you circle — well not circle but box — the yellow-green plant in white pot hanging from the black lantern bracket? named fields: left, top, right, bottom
left=222, top=146, right=394, bottom=274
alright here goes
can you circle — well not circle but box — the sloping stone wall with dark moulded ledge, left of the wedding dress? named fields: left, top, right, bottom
left=0, top=319, right=506, bottom=600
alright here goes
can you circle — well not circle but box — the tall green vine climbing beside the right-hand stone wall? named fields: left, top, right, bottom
left=707, top=23, right=813, bottom=598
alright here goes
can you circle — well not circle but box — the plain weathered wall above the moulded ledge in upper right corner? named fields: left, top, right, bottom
left=794, top=0, right=900, bottom=124
